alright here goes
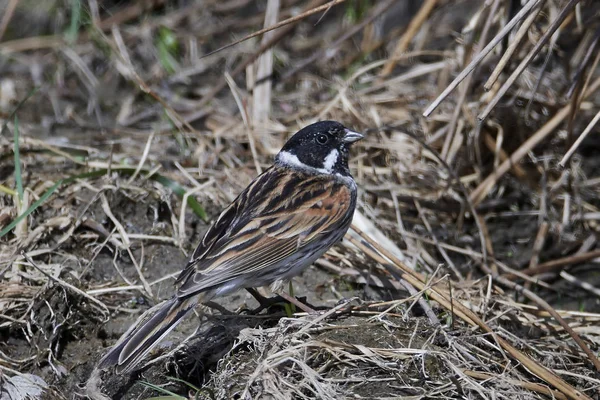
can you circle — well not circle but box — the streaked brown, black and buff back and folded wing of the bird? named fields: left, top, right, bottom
left=177, top=167, right=353, bottom=298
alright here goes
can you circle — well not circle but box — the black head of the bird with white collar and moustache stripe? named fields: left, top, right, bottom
left=276, top=121, right=363, bottom=175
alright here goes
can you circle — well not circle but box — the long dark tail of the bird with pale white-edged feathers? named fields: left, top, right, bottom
left=97, top=296, right=198, bottom=372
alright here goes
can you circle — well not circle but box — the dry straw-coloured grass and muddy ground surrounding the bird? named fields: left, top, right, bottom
left=0, top=0, right=600, bottom=399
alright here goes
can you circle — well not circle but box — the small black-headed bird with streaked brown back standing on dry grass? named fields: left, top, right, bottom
left=98, top=121, right=363, bottom=372
